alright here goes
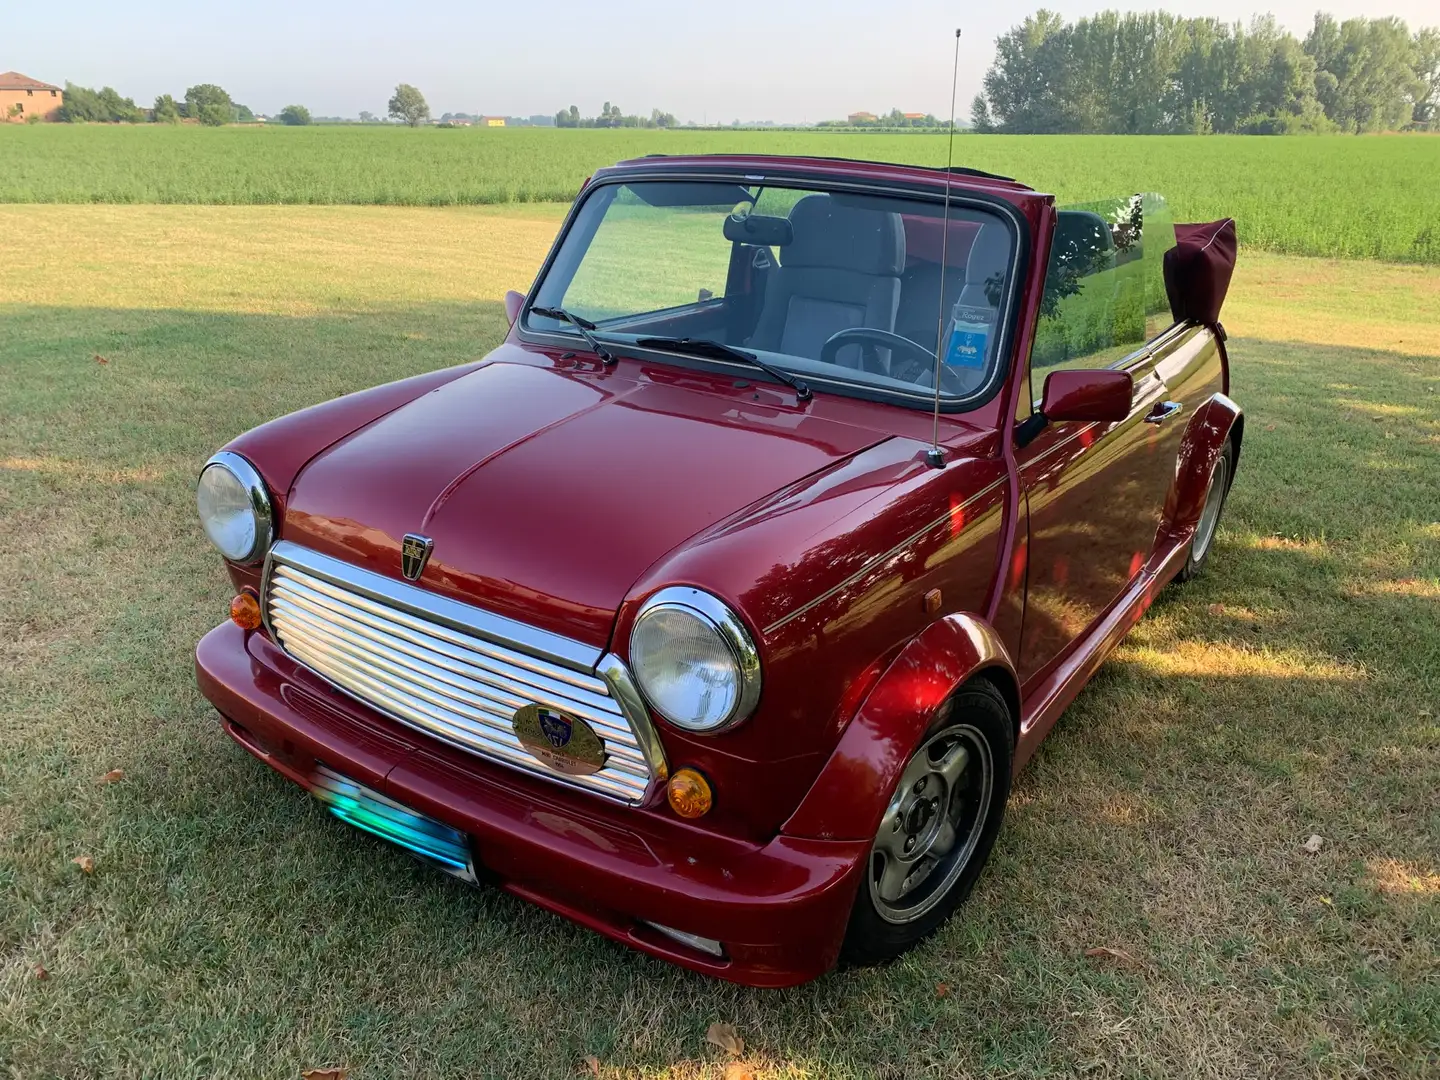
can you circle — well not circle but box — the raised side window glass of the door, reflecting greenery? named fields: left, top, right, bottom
left=1030, top=194, right=1175, bottom=392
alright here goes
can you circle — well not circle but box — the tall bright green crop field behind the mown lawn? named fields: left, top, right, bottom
left=0, top=125, right=1440, bottom=264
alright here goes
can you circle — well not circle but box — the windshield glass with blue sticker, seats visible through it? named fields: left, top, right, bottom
left=523, top=180, right=1014, bottom=402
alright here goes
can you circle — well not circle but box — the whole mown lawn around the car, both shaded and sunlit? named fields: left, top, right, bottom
left=0, top=206, right=1440, bottom=1080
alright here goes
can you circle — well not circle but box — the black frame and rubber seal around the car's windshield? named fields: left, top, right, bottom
left=514, top=160, right=1032, bottom=413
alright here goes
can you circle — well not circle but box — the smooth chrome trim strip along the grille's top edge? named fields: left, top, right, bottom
left=265, top=540, right=600, bottom=672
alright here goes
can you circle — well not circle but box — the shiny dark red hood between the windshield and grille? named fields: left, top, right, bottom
left=282, top=360, right=886, bottom=648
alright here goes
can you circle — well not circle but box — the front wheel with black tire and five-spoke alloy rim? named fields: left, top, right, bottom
left=841, top=680, right=1014, bottom=965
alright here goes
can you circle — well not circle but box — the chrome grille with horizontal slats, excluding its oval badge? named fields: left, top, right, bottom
left=265, top=541, right=665, bottom=802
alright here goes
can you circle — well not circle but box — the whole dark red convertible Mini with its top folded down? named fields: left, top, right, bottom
left=196, top=157, right=1243, bottom=986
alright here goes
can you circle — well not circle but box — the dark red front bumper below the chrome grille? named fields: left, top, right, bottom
left=196, top=622, right=870, bottom=986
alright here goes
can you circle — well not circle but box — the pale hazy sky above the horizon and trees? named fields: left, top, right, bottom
left=11, top=0, right=1440, bottom=124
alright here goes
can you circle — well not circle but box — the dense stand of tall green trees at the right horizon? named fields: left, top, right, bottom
left=971, top=10, right=1440, bottom=135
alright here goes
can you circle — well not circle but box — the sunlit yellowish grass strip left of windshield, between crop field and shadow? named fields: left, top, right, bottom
left=0, top=204, right=566, bottom=316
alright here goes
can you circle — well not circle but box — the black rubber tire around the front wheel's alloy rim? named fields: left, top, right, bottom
left=841, top=678, right=1015, bottom=966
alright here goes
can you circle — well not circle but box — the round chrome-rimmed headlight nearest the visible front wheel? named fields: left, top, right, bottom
left=629, top=588, right=760, bottom=732
